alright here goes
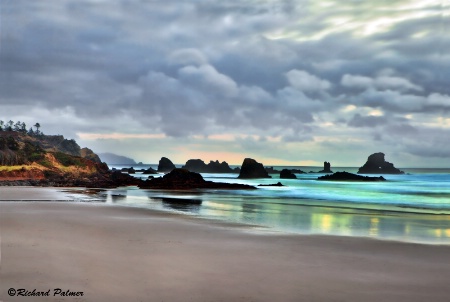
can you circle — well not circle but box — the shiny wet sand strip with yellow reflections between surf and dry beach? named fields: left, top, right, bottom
left=103, top=191, right=450, bottom=244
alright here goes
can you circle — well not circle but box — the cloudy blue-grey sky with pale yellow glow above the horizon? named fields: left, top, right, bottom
left=0, top=0, right=450, bottom=168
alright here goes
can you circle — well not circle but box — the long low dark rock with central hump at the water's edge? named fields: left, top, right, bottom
left=139, top=168, right=256, bottom=190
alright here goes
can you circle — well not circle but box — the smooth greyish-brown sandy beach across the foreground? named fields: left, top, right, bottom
left=0, top=188, right=450, bottom=302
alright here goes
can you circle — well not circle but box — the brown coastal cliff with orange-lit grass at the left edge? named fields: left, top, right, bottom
left=0, top=131, right=140, bottom=188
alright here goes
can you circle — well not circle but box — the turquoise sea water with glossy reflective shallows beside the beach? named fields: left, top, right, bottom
left=106, top=167, right=450, bottom=244
